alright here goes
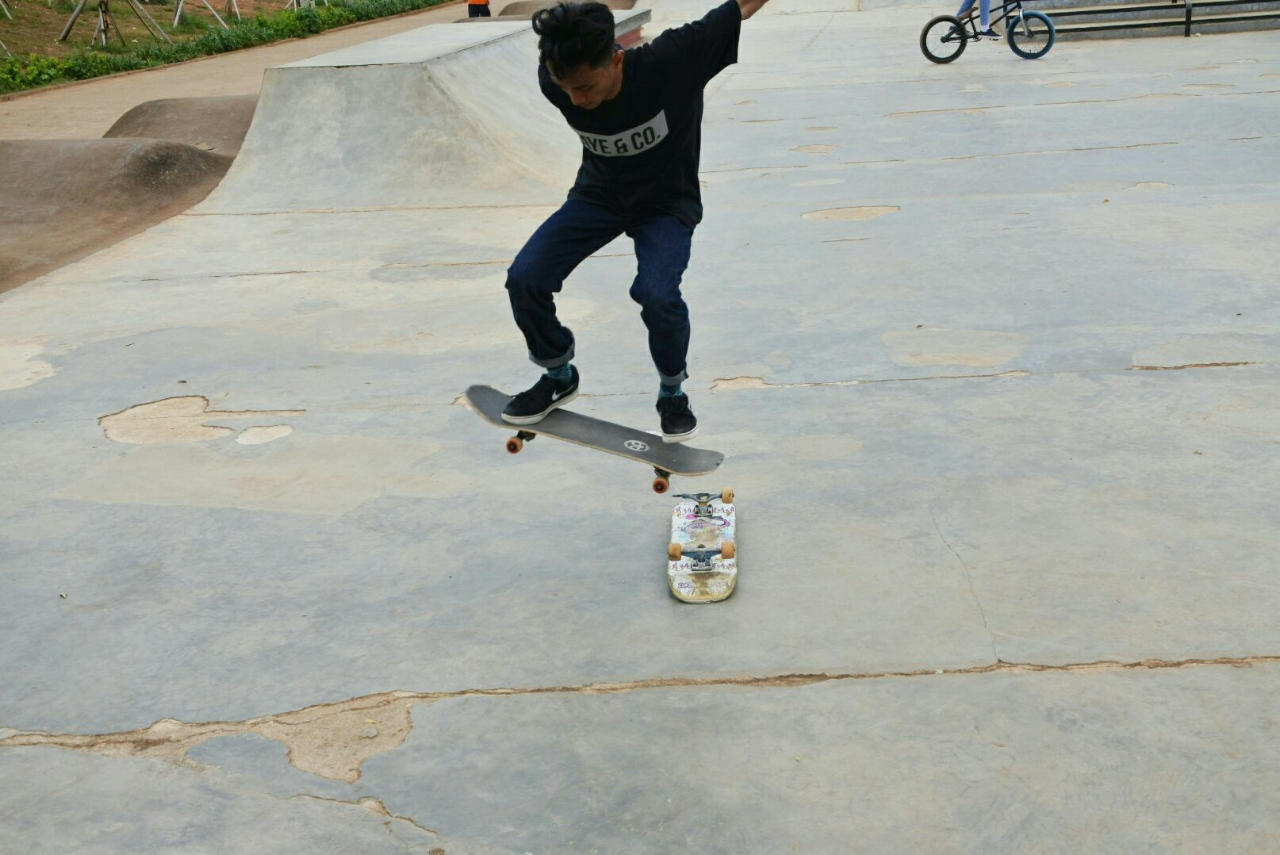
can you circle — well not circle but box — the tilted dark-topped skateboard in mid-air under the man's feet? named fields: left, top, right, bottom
left=467, top=385, right=724, bottom=493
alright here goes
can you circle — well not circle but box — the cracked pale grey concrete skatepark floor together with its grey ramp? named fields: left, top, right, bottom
left=0, top=0, right=1280, bottom=855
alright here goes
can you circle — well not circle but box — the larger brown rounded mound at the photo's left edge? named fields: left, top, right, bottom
left=0, top=140, right=232, bottom=292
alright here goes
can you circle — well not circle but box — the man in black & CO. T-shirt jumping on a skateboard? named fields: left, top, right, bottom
left=502, top=0, right=768, bottom=443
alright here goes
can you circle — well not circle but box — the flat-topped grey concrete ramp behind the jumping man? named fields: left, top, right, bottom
left=200, top=10, right=649, bottom=214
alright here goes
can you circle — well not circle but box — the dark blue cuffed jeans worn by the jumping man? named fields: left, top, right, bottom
left=507, top=198, right=694, bottom=384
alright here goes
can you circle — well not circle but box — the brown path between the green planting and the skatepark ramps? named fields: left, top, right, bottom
left=0, top=3, right=471, bottom=140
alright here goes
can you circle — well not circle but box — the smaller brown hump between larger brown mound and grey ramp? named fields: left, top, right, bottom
left=102, top=95, right=257, bottom=157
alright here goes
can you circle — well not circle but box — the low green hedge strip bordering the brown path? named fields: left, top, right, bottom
left=0, top=0, right=444, bottom=92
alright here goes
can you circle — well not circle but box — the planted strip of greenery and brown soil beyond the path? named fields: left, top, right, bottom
left=0, top=0, right=447, bottom=93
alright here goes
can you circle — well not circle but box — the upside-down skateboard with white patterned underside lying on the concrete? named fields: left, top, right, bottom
left=667, top=490, right=737, bottom=603
